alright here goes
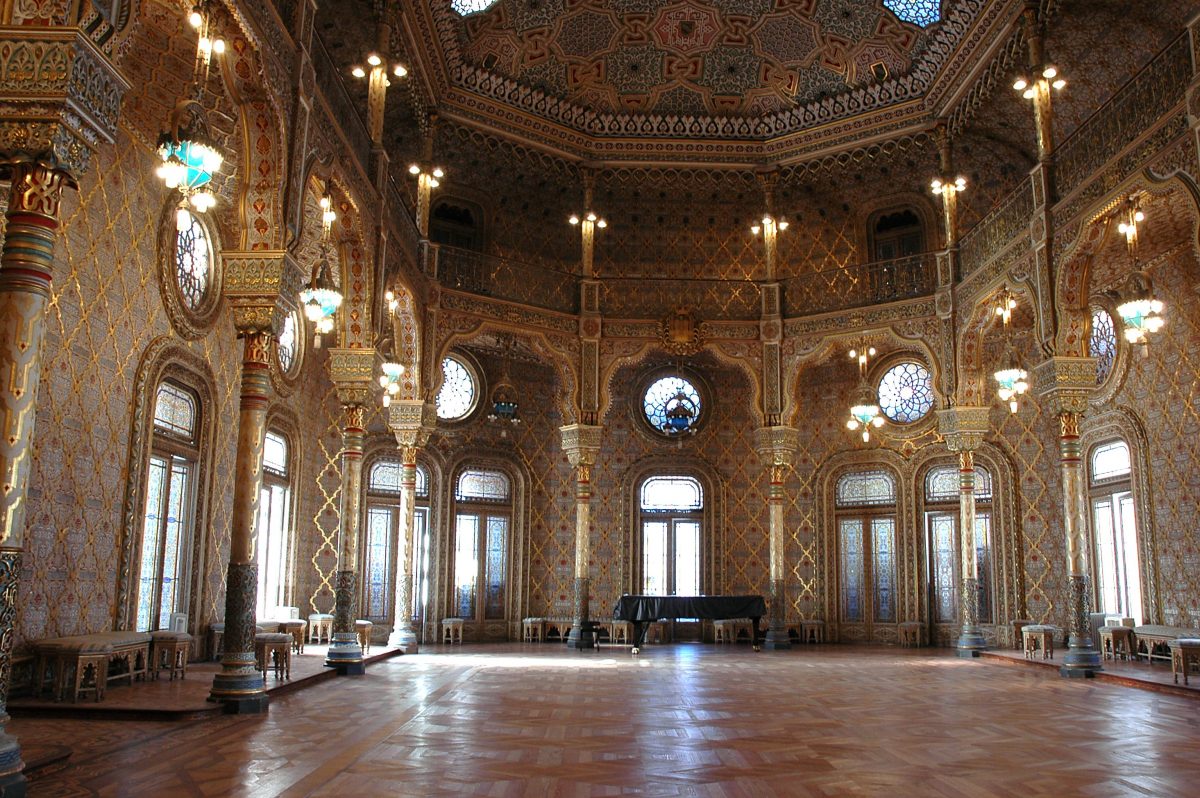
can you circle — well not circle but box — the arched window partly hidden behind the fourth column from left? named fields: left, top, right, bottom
left=362, top=460, right=430, bottom=623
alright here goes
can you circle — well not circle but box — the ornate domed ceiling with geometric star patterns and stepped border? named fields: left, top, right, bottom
left=402, top=0, right=1021, bottom=163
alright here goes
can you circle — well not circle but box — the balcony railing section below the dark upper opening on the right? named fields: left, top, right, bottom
left=782, top=252, right=937, bottom=317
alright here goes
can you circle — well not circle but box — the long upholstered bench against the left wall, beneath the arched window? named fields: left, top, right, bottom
left=32, top=631, right=151, bottom=701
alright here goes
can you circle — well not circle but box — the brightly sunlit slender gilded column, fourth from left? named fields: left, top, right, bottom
left=388, top=400, right=437, bottom=654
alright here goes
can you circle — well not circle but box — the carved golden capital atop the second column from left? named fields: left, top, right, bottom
left=221, top=250, right=304, bottom=337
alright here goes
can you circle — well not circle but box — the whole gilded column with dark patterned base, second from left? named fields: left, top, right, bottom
left=209, top=250, right=302, bottom=713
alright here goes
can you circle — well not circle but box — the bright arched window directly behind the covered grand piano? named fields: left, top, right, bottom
left=641, top=475, right=704, bottom=595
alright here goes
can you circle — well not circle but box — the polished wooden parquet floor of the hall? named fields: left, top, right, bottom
left=12, top=644, right=1200, bottom=798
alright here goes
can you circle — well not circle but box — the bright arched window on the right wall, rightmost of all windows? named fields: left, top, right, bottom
left=1087, top=439, right=1142, bottom=624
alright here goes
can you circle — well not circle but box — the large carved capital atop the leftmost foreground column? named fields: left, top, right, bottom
left=0, top=28, right=130, bottom=182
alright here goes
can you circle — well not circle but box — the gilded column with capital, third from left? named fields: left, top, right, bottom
left=325, top=348, right=376, bottom=676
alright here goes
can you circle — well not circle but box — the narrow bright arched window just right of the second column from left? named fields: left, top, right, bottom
left=257, top=430, right=293, bottom=618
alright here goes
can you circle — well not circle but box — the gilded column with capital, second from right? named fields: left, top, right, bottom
left=937, top=407, right=989, bottom=656
